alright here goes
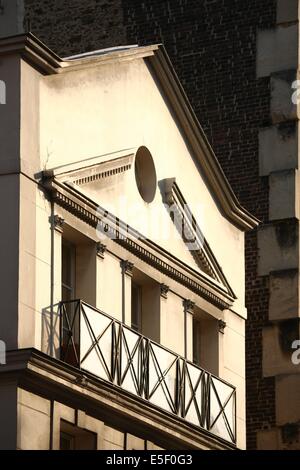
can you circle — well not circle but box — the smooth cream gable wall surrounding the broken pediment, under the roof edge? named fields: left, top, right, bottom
left=36, top=59, right=245, bottom=314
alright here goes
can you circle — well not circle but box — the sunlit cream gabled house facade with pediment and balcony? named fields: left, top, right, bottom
left=0, top=34, right=258, bottom=449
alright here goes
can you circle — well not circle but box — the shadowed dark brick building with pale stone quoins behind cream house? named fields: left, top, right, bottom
left=0, top=0, right=300, bottom=449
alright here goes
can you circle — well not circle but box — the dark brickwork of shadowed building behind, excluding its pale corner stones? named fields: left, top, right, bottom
left=26, top=0, right=276, bottom=449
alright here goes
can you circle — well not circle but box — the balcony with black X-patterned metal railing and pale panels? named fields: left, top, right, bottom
left=59, top=300, right=236, bottom=444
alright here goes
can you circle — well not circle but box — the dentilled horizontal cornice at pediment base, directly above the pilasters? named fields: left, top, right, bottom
left=42, top=178, right=234, bottom=310
